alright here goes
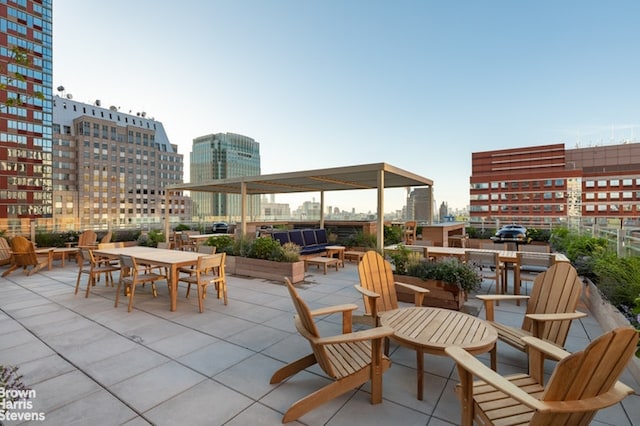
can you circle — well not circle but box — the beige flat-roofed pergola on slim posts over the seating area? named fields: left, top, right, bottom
left=165, top=163, right=433, bottom=249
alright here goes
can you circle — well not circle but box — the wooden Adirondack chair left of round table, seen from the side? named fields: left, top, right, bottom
left=270, top=278, right=393, bottom=423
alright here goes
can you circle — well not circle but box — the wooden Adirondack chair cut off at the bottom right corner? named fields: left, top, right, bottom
left=446, top=327, right=638, bottom=426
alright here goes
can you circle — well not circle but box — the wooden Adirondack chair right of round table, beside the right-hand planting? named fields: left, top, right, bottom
left=476, top=262, right=587, bottom=370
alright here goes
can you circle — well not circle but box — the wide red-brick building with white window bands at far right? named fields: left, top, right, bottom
left=469, top=143, right=640, bottom=225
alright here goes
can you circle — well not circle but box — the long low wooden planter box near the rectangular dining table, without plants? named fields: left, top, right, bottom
left=231, top=256, right=304, bottom=284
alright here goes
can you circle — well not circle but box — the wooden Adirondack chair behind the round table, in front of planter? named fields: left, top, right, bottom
left=355, top=250, right=429, bottom=327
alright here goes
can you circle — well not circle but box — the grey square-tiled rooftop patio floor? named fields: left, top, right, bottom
left=0, top=262, right=640, bottom=426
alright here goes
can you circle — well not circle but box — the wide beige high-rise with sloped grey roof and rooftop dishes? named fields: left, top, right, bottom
left=52, top=96, right=192, bottom=229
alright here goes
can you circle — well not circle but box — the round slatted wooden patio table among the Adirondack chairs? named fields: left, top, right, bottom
left=380, top=307, right=498, bottom=401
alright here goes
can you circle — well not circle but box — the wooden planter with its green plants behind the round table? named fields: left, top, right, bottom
left=389, top=245, right=482, bottom=310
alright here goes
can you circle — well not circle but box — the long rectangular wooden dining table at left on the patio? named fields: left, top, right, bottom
left=93, top=246, right=202, bottom=312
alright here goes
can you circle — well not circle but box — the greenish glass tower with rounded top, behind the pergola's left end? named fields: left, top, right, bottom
left=189, top=133, right=260, bottom=220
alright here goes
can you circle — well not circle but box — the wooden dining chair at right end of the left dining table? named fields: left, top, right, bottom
left=178, top=252, right=227, bottom=313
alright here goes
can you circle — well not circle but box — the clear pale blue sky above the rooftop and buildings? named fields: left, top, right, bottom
left=53, top=0, right=640, bottom=212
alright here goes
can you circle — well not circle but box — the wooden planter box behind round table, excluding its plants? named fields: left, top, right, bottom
left=393, top=274, right=465, bottom=311
